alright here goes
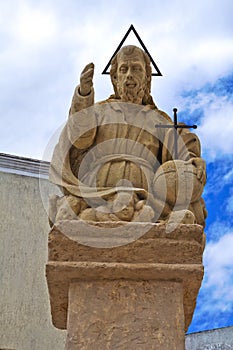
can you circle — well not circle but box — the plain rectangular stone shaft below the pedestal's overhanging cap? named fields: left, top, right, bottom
left=66, top=280, right=184, bottom=350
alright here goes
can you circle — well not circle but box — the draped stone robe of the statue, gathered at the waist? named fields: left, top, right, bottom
left=50, top=88, right=206, bottom=226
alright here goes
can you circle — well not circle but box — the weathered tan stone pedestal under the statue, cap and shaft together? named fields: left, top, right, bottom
left=46, top=221, right=204, bottom=350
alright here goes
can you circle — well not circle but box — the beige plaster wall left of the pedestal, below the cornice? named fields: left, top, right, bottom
left=0, top=172, right=66, bottom=350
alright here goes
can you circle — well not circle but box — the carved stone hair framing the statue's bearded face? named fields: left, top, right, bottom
left=110, top=45, right=155, bottom=106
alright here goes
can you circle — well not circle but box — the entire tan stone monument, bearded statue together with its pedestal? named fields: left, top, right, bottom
left=46, top=45, right=207, bottom=350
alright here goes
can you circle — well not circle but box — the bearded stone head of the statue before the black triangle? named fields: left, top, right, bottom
left=110, top=45, right=154, bottom=105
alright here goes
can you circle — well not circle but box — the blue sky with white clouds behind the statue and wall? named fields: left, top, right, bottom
left=0, top=0, right=233, bottom=332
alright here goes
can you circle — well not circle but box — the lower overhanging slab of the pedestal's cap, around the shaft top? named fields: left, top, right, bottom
left=46, top=261, right=203, bottom=331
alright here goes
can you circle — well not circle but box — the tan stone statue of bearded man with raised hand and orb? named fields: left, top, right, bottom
left=50, top=45, right=207, bottom=226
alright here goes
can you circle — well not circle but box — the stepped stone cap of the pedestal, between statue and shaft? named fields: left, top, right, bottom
left=46, top=221, right=203, bottom=331
